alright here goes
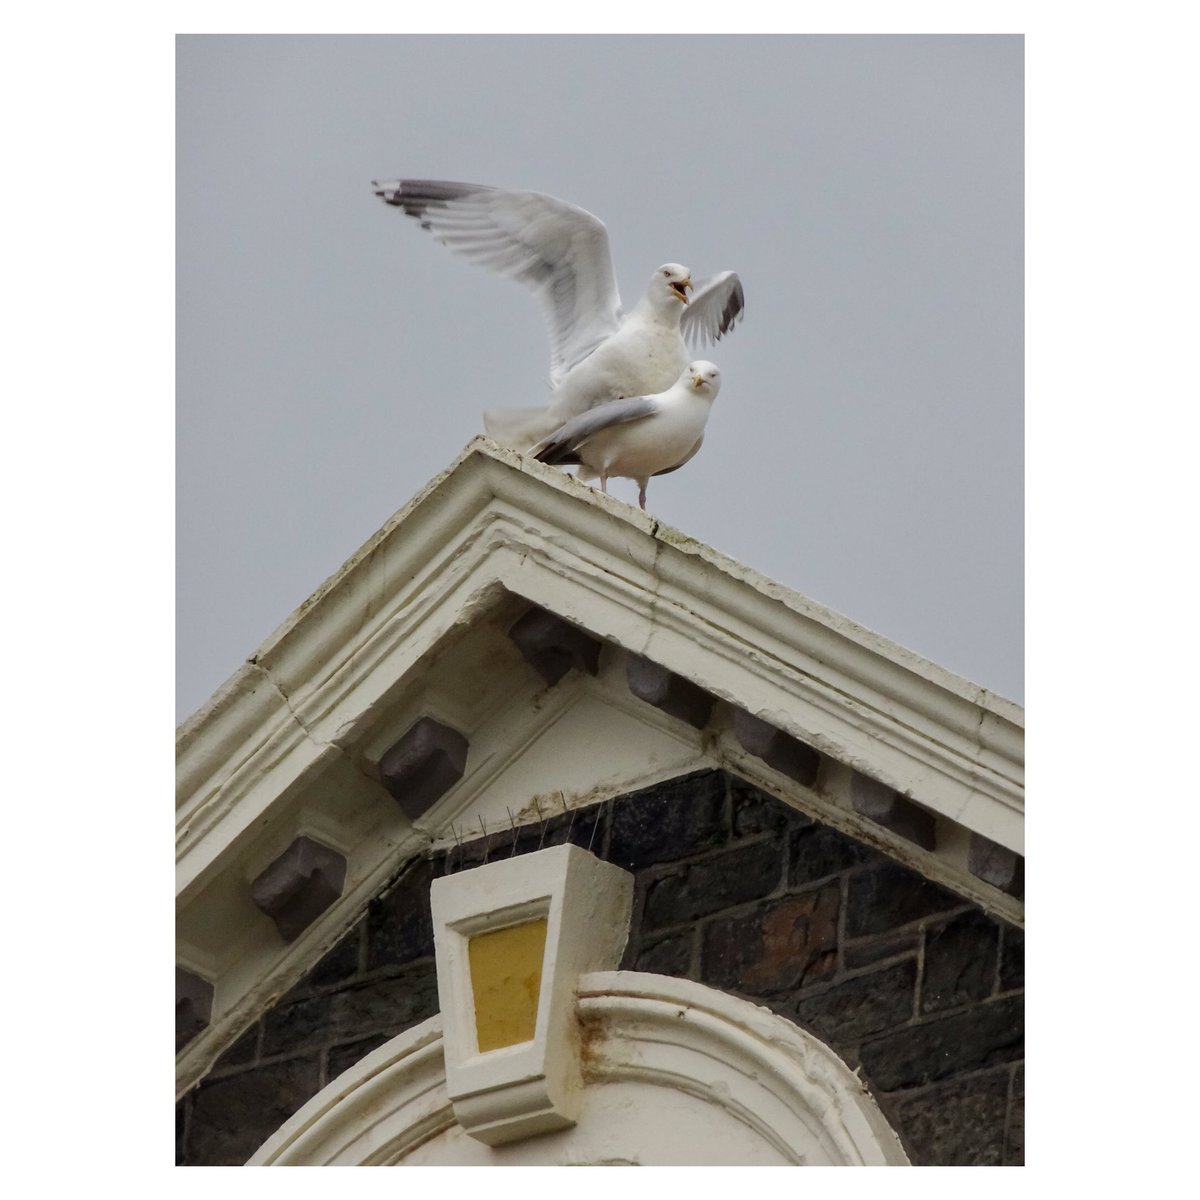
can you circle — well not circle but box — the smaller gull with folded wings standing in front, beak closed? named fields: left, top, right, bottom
left=529, top=360, right=721, bottom=509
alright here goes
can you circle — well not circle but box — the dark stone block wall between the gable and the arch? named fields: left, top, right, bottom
left=176, top=772, right=1025, bottom=1166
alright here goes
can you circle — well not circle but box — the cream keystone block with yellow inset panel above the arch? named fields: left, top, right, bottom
left=431, top=845, right=634, bottom=1146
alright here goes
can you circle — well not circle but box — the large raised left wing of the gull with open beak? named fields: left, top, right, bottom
left=374, top=179, right=620, bottom=384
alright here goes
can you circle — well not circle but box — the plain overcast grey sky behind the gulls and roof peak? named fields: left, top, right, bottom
left=176, top=36, right=1024, bottom=720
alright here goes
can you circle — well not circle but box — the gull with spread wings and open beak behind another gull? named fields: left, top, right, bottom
left=374, top=179, right=745, bottom=450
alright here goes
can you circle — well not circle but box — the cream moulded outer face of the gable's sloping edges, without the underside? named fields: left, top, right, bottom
left=178, top=438, right=1024, bottom=868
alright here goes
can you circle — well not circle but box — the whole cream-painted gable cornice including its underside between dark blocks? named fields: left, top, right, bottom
left=176, top=438, right=1024, bottom=1099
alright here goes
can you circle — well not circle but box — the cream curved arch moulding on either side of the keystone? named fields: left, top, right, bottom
left=250, top=971, right=907, bottom=1166
